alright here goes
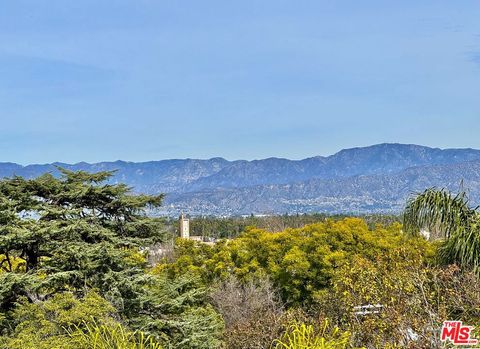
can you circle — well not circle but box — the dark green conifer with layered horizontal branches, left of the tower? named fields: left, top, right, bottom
left=0, top=169, right=164, bottom=311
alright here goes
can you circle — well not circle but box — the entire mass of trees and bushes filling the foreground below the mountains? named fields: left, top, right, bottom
left=0, top=170, right=480, bottom=349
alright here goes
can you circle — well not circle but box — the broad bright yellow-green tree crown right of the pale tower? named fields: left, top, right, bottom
left=157, top=218, right=434, bottom=305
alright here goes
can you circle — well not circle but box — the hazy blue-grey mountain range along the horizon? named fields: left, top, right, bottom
left=0, top=143, right=480, bottom=216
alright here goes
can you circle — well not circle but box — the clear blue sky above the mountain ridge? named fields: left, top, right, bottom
left=0, top=0, right=480, bottom=164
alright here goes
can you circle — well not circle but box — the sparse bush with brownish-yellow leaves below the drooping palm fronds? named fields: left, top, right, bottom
left=317, top=255, right=480, bottom=348
